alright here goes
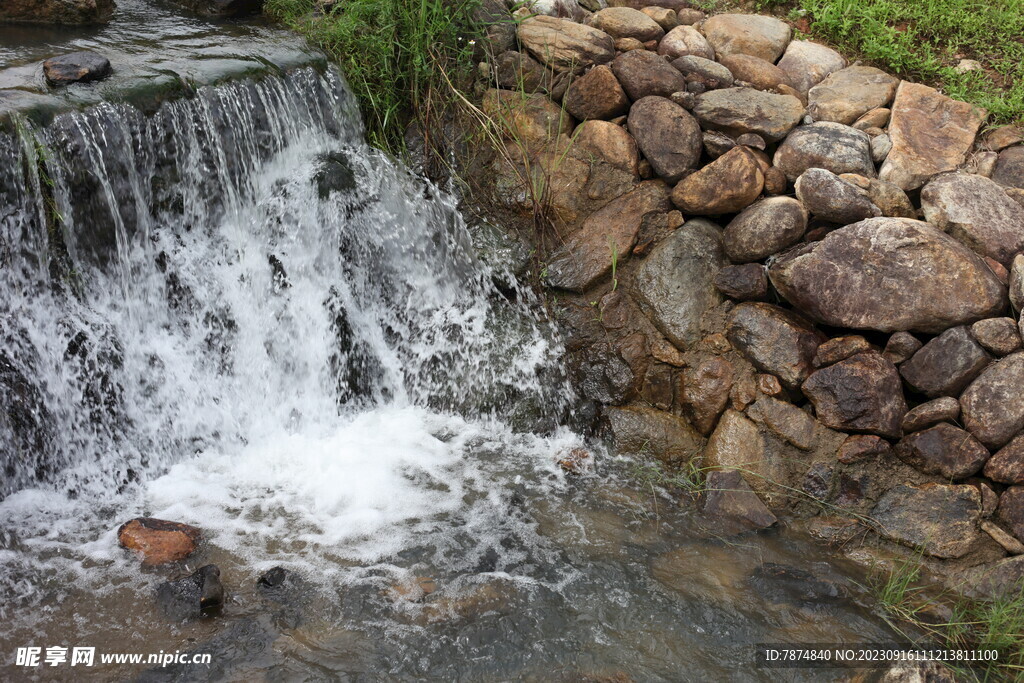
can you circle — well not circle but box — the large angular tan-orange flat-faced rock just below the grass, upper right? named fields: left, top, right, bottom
left=879, top=81, right=986, bottom=189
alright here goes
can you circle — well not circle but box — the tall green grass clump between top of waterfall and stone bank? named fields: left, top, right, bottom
left=265, top=0, right=479, bottom=154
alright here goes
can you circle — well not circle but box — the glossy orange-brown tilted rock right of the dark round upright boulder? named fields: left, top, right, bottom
left=667, top=146, right=764, bottom=216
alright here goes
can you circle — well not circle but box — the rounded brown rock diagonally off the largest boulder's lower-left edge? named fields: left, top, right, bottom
left=726, top=303, right=825, bottom=389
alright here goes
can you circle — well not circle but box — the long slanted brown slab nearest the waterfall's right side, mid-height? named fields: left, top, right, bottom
left=548, top=180, right=671, bottom=292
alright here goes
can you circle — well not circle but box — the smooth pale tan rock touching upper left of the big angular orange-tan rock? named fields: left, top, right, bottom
left=807, top=67, right=900, bottom=125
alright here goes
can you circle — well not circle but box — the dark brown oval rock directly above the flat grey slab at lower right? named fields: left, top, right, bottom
left=894, top=422, right=988, bottom=479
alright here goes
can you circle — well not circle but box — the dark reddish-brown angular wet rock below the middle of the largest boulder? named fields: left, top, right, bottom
left=802, top=351, right=906, bottom=438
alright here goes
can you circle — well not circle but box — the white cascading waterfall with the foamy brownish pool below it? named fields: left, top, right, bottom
left=0, top=69, right=897, bottom=680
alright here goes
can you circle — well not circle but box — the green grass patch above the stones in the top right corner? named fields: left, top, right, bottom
left=745, top=0, right=1024, bottom=123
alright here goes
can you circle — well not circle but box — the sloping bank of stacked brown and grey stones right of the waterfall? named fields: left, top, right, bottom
left=479, top=0, right=1024, bottom=589
